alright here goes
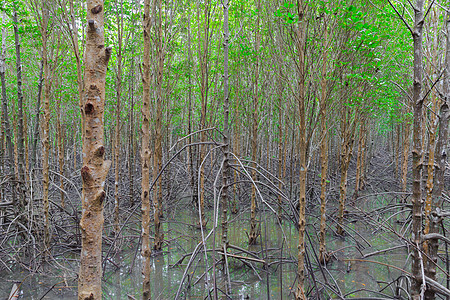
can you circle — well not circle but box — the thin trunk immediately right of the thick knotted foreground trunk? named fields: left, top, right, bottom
left=114, top=1, right=123, bottom=235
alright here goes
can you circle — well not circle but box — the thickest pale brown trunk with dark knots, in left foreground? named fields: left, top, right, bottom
left=78, top=0, right=111, bottom=300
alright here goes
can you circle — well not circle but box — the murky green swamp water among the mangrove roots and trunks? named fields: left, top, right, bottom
left=0, top=196, right=409, bottom=300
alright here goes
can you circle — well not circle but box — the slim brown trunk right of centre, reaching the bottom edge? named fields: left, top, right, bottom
left=295, top=0, right=307, bottom=299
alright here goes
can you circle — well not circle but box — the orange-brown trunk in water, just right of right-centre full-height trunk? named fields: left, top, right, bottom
left=319, top=21, right=329, bottom=263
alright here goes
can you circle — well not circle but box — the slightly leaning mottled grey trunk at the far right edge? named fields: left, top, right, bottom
left=425, top=14, right=450, bottom=299
